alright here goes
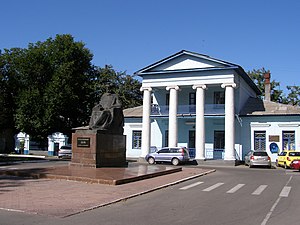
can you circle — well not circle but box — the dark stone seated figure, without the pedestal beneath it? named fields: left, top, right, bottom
left=89, top=91, right=124, bottom=134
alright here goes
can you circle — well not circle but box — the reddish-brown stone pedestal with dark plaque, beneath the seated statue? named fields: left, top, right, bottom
left=70, top=129, right=127, bottom=168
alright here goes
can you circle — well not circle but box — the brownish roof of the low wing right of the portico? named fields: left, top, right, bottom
left=240, top=98, right=300, bottom=116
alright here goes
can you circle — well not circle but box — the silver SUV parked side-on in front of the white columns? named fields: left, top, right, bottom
left=145, top=147, right=190, bottom=166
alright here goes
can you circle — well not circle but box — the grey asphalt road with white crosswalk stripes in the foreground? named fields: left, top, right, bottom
left=0, top=166, right=300, bottom=225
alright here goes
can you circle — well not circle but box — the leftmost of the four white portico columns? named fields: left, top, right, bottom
left=141, top=87, right=152, bottom=158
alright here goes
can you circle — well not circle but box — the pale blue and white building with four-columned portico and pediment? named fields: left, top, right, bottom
left=124, top=50, right=300, bottom=162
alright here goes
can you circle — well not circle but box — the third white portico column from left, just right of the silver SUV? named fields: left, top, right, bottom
left=193, top=84, right=206, bottom=160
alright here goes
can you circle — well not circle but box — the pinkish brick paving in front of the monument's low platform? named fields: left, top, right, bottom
left=0, top=163, right=215, bottom=217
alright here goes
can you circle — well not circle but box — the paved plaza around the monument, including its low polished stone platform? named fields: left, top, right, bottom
left=0, top=162, right=215, bottom=217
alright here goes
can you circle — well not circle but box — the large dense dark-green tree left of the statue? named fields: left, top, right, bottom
left=6, top=35, right=93, bottom=138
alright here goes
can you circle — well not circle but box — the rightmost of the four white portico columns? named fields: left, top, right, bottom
left=221, top=83, right=236, bottom=160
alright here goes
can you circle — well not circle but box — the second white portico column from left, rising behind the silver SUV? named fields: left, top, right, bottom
left=166, top=86, right=179, bottom=147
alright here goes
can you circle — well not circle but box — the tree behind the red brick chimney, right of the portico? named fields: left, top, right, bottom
left=247, top=67, right=284, bottom=102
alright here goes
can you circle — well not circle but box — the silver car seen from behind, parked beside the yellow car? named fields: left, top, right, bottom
left=245, top=151, right=272, bottom=168
